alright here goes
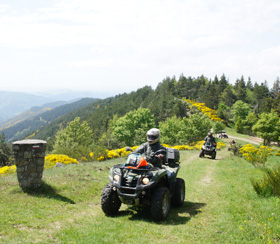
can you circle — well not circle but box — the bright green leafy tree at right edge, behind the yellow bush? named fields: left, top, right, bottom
left=252, top=110, right=280, bottom=145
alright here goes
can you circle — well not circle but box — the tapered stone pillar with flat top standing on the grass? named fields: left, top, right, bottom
left=13, top=140, right=47, bottom=191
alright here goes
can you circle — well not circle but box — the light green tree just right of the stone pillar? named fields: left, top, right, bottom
left=53, top=117, right=93, bottom=158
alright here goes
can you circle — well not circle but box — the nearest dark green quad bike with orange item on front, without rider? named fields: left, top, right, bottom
left=101, top=147, right=185, bottom=221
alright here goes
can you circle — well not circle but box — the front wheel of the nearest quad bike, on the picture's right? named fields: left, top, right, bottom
left=151, top=186, right=170, bottom=221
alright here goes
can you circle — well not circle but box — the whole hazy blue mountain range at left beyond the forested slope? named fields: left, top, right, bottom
left=0, top=91, right=99, bottom=142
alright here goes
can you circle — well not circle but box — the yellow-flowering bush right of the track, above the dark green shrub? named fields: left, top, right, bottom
left=239, top=144, right=275, bottom=167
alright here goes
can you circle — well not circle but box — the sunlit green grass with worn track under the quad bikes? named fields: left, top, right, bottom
left=0, top=149, right=280, bottom=243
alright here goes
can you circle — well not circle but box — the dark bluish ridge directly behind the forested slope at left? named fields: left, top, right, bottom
left=0, top=98, right=98, bottom=142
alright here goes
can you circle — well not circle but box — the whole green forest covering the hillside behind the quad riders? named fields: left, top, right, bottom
left=0, top=74, right=280, bottom=163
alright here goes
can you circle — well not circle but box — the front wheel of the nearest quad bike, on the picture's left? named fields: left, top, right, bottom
left=101, top=184, right=122, bottom=216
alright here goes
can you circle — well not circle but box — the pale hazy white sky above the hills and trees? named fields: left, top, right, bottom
left=0, top=0, right=280, bottom=95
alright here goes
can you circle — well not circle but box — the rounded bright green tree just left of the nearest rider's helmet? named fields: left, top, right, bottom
left=112, top=108, right=155, bottom=146
